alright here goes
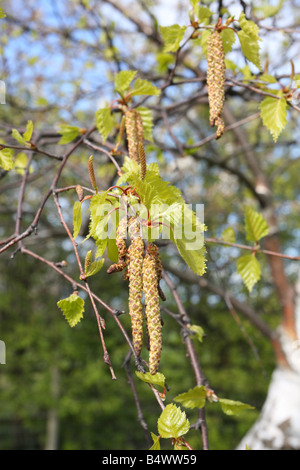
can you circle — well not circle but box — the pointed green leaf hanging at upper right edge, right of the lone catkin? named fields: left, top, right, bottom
left=260, top=96, right=287, bottom=142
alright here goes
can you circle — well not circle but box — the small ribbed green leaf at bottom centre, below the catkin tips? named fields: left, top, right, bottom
left=157, top=403, right=190, bottom=439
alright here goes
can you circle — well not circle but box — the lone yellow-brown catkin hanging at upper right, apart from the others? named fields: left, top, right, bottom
left=207, top=31, right=226, bottom=138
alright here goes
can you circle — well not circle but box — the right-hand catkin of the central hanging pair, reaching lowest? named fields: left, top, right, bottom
left=143, top=244, right=162, bottom=375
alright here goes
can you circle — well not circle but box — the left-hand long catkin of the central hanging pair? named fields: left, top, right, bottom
left=127, top=219, right=144, bottom=356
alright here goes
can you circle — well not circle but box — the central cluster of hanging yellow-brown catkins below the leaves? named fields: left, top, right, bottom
left=107, top=217, right=165, bottom=375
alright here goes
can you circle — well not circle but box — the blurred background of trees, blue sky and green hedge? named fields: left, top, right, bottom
left=0, top=0, right=300, bottom=449
